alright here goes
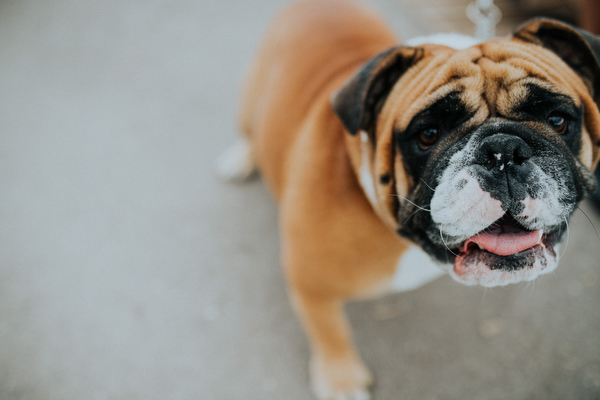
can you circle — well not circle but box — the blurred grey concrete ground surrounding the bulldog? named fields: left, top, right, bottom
left=0, top=0, right=600, bottom=400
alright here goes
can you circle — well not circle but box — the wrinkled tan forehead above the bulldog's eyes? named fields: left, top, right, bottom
left=381, top=40, right=586, bottom=130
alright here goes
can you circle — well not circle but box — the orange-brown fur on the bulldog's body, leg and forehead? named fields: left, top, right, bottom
left=242, top=0, right=600, bottom=397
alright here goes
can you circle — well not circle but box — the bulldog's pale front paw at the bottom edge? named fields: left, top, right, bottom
left=310, top=357, right=373, bottom=400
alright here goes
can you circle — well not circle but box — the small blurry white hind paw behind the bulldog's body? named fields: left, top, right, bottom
left=216, top=138, right=257, bottom=182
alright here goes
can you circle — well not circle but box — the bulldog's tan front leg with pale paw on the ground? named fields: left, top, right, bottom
left=291, top=291, right=372, bottom=400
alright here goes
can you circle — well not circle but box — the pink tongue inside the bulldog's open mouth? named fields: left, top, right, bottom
left=463, top=230, right=540, bottom=256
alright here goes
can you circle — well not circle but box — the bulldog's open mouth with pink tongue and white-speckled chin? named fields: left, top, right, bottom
left=451, top=214, right=560, bottom=286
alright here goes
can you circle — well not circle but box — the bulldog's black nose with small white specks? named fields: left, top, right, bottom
left=476, top=133, right=533, bottom=171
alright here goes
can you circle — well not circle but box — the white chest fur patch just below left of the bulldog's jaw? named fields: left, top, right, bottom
left=392, top=246, right=446, bottom=292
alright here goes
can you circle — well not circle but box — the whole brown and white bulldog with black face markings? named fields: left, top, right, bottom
left=218, top=0, right=600, bottom=399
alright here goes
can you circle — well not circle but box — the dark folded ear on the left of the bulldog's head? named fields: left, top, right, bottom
left=331, top=47, right=425, bottom=135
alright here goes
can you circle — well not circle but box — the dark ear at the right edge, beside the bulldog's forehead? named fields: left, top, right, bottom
left=514, top=19, right=600, bottom=103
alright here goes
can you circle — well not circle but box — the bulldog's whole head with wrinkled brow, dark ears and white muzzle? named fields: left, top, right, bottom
left=332, top=20, right=600, bottom=286
